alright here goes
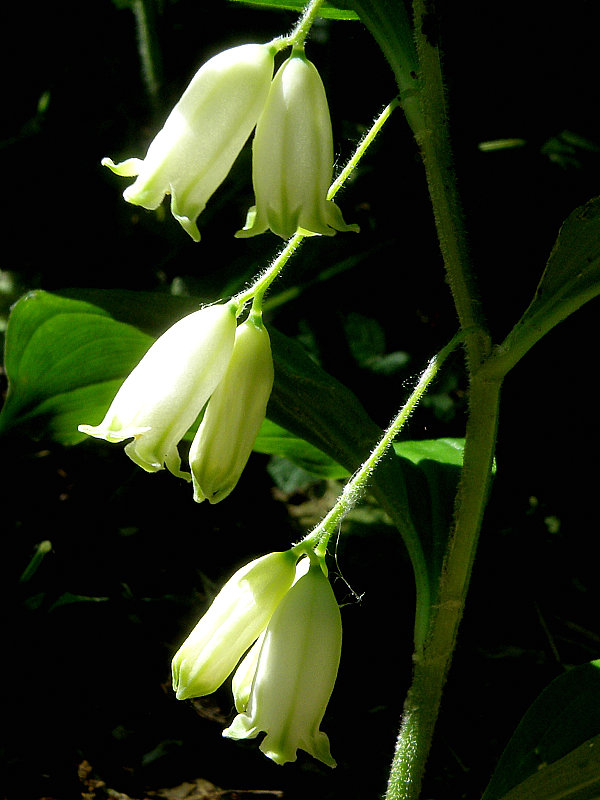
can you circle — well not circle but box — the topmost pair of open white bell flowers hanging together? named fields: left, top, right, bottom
left=102, top=43, right=358, bottom=241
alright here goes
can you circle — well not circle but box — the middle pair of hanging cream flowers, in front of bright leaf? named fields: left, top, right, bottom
left=79, top=302, right=273, bottom=503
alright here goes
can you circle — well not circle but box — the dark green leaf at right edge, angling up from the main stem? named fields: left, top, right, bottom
left=489, top=197, right=600, bottom=373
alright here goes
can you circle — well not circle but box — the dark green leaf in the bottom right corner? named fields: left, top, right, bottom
left=482, top=660, right=600, bottom=800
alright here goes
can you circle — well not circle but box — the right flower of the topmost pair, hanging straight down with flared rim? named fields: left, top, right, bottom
left=236, top=50, right=358, bottom=239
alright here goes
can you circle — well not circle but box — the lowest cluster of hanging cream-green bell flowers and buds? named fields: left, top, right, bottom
left=173, top=549, right=342, bottom=767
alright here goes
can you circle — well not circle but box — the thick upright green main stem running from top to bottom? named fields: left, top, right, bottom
left=386, top=0, right=501, bottom=800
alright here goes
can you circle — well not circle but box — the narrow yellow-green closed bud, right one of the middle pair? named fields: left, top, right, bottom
left=189, top=315, right=273, bottom=503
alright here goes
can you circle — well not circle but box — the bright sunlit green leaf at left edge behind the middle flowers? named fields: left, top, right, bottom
left=0, top=291, right=152, bottom=444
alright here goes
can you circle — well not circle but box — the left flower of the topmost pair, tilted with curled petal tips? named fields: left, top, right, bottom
left=102, top=44, right=274, bottom=241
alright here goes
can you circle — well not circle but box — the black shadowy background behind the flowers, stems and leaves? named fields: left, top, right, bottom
left=0, top=0, right=600, bottom=800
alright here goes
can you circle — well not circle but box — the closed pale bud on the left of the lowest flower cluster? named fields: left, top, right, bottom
left=172, top=550, right=298, bottom=700
